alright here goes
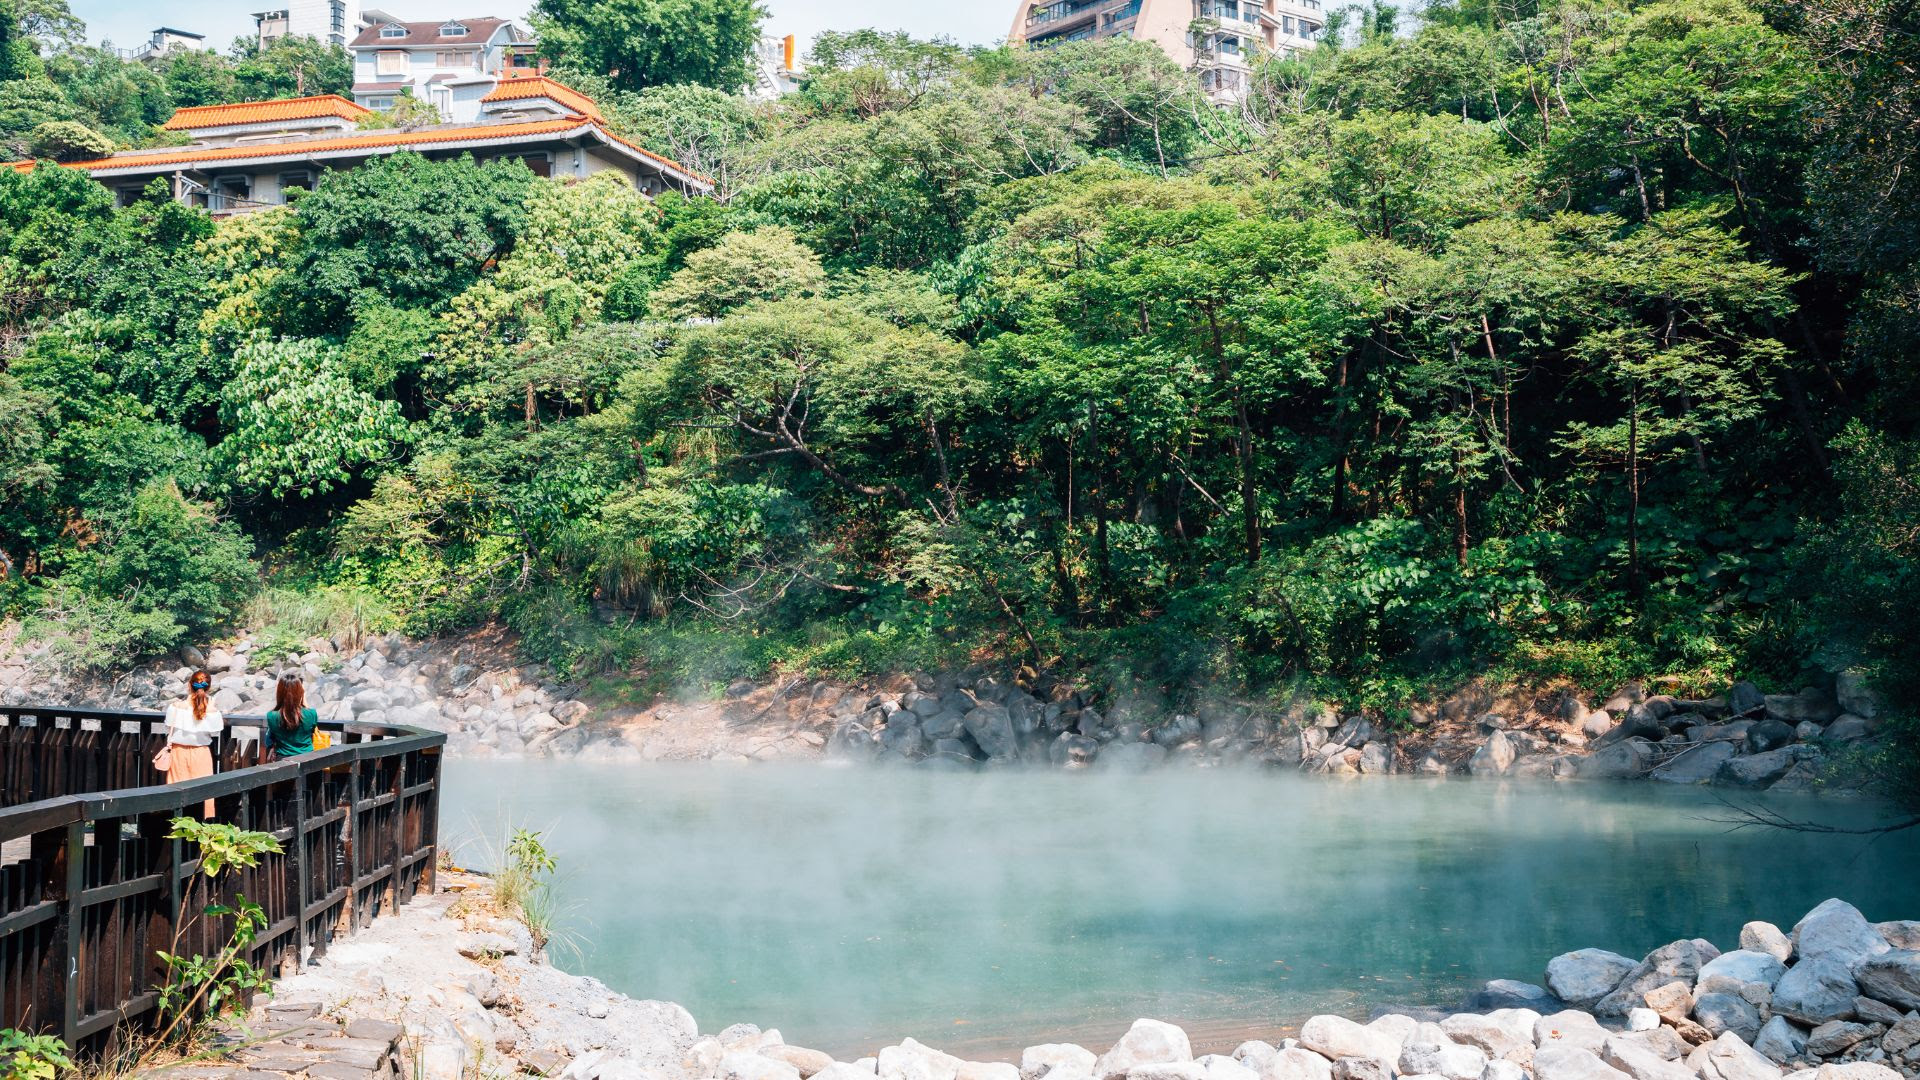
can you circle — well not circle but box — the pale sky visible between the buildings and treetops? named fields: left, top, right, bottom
left=69, top=0, right=1016, bottom=52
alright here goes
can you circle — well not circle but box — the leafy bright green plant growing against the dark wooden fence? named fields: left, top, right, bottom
left=142, top=817, right=280, bottom=1057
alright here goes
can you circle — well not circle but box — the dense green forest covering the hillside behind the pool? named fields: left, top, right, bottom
left=0, top=0, right=1920, bottom=791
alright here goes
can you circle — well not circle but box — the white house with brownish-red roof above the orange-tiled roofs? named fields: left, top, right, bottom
left=348, top=12, right=538, bottom=123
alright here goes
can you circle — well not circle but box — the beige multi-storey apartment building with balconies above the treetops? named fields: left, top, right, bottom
left=1006, top=0, right=1327, bottom=102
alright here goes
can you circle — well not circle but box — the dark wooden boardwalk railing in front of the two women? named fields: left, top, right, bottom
left=0, top=705, right=445, bottom=1047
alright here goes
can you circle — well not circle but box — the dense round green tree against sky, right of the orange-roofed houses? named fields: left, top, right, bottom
left=534, top=0, right=766, bottom=90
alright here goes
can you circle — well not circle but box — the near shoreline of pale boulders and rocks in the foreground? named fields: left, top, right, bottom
left=142, top=871, right=1920, bottom=1080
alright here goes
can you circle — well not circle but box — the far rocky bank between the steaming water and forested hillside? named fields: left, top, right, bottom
left=0, top=632, right=1884, bottom=790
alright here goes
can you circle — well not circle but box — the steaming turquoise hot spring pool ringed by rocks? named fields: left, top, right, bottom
left=442, top=761, right=1920, bottom=1059
